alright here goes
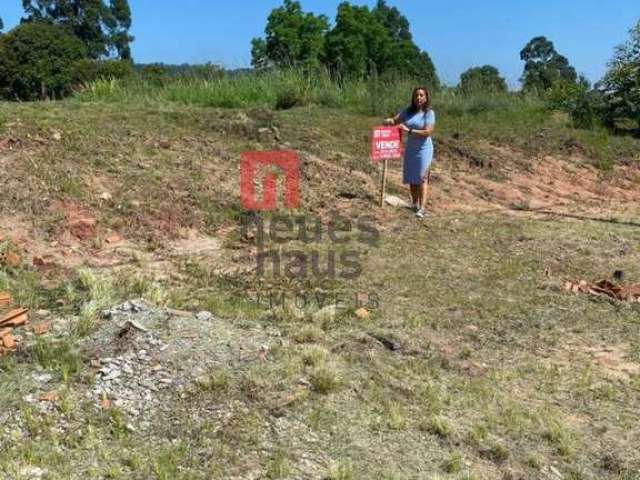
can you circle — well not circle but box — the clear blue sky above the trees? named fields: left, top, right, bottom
left=0, top=0, right=640, bottom=87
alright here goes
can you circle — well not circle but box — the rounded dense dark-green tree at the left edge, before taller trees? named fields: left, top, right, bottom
left=0, top=23, right=86, bottom=100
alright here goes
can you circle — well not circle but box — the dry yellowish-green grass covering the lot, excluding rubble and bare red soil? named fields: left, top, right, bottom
left=0, top=99, right=640, bottom=480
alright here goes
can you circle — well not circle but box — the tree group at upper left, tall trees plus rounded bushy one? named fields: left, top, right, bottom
left=0, top=0, right=133, bottom=100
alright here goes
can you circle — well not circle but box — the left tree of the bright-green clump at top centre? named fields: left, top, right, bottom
left=251, top=0, right=329, bottom=67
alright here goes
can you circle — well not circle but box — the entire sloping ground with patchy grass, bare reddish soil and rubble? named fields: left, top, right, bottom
left=0, top=101, right=640, bottom=479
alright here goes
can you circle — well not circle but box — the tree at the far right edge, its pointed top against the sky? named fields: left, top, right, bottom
left=598, top=21, right=640, bottom=128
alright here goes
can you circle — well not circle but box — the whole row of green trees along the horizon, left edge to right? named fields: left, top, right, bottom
left=0, top=0, right=640, bottom=128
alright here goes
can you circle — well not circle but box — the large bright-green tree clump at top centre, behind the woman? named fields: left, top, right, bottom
left=251, top=0, right=439, bottom=87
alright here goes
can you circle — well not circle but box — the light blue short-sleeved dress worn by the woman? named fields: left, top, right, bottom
left=400, top=109, right=436, bottom=185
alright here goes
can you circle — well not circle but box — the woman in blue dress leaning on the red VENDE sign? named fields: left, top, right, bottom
left=384, top=87, right=436, bottom=218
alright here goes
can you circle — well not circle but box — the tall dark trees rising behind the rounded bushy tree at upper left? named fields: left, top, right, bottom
left=22, top=0, right=133, bottom=60
